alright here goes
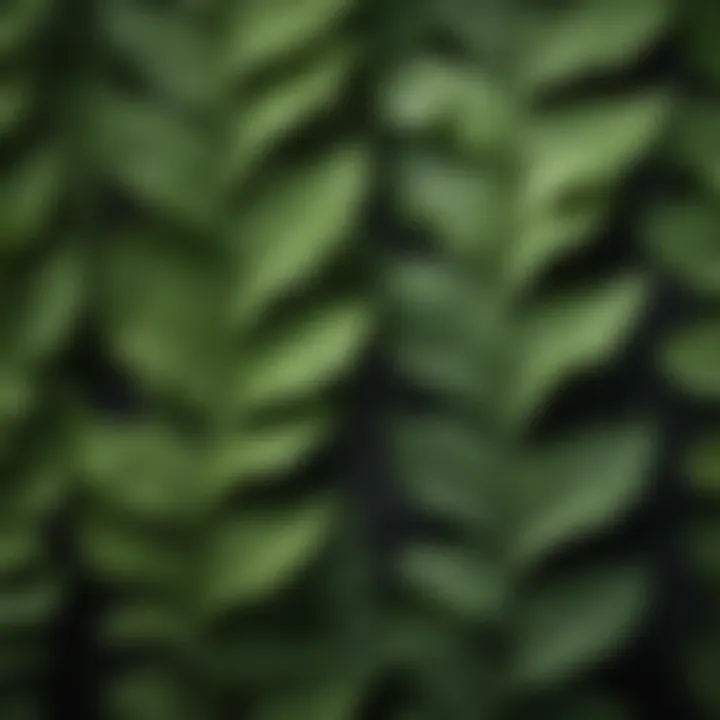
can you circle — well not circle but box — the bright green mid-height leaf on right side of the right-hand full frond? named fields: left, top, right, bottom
left=513, top=275, right=646, bottom=419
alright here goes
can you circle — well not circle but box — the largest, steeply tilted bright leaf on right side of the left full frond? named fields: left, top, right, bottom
left=231, top=145, right=369, bottom=321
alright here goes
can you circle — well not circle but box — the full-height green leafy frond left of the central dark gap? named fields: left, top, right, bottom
left=78, top=0, right=371, bottom=720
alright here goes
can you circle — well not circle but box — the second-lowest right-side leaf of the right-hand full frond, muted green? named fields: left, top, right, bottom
left=512, top=425, right=654, bottom=564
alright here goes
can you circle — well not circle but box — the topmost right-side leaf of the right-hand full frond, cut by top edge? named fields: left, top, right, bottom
left=523, top=0, right=673, bottom=90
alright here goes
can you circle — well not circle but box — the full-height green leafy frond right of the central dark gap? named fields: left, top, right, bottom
left=379, top=0, right=671, bottom=719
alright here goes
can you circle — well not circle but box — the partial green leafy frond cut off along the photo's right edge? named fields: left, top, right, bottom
left=647, top=0, right=720, bottom=718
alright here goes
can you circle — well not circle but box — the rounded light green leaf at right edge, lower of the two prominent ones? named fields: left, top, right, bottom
left=661, top=319, right=720, bottom=399
